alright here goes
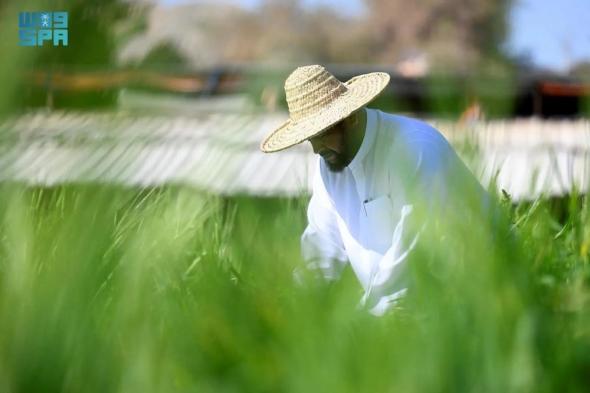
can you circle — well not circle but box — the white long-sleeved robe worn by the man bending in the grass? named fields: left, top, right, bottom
left=301, top=109, right=486, bottom=315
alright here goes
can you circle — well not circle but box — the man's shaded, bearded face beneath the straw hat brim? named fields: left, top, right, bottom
left=309, top=119, right=349, bottom=172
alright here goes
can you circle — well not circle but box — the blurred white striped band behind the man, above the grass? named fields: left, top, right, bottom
left=0, top=111, right=590, bottom=199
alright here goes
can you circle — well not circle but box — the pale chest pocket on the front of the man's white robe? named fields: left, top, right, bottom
left=360, top=195, right=394, bottom=252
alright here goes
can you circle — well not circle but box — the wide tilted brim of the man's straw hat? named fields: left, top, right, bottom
left=260, top=72, right=389, bottom=153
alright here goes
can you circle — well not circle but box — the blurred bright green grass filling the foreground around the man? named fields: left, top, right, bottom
left=0, top=184, right=590, bottom=392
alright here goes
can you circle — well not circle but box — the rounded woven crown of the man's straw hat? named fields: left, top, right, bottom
left=285, top=65, right=348, bottom=122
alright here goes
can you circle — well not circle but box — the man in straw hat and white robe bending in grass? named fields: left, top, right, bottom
left=261, top=65, right=483, bottom=315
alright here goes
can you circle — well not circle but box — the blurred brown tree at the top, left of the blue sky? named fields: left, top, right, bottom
left=365, top=0, right=510, bottom=71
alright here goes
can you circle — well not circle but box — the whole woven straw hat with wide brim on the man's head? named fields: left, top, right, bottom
left=260, top=65, right=389, bottom=153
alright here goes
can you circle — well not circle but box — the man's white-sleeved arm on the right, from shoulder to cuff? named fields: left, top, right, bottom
left=363, top=133, right=462, bottom=315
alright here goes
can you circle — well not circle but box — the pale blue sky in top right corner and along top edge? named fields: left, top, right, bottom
left=158, top=0, right=590, bottom=72
